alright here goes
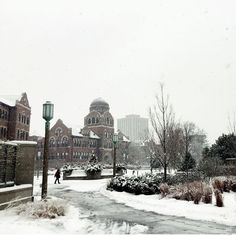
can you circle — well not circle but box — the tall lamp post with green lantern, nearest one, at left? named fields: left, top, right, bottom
left=41, top=101, right=54, bottom=200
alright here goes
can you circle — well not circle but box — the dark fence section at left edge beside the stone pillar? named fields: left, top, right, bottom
left=0, top=142, right=17, bottom=188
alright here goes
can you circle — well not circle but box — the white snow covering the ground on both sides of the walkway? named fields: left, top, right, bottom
left=0, top=172, right=236, bottom=234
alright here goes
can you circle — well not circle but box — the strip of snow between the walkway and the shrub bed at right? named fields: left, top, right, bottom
left=101, top=187, right=236, bottom=226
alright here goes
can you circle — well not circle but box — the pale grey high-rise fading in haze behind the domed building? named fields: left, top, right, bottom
left=117, top=115, right=148, bottom=143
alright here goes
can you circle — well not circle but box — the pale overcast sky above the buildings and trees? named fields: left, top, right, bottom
left=0, top=0, right=236, bottom=143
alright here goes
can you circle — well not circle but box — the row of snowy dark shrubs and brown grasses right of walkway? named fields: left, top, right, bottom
left=107, top=174, right=236, bottom=207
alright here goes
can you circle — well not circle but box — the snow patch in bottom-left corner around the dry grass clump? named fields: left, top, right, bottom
left=0, top=198, right=82, bottom=234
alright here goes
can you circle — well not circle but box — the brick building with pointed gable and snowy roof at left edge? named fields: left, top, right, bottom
left=0, top=93, right=31, bottom=140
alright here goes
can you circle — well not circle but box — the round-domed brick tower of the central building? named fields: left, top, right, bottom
left=83, top=98, right=114, bottom=163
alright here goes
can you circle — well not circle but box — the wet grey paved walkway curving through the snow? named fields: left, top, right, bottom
left=49, top=186, right=236, bottom=234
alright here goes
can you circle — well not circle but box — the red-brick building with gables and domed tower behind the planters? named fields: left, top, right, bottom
left=30, top=98, right=129, bottom=167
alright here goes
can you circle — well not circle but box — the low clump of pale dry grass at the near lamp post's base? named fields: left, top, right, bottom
left=16, top=199, right=68, bottom=219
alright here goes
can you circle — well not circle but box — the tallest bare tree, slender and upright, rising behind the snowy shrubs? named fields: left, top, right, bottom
left=148, top=84, right=176, bottom=181
